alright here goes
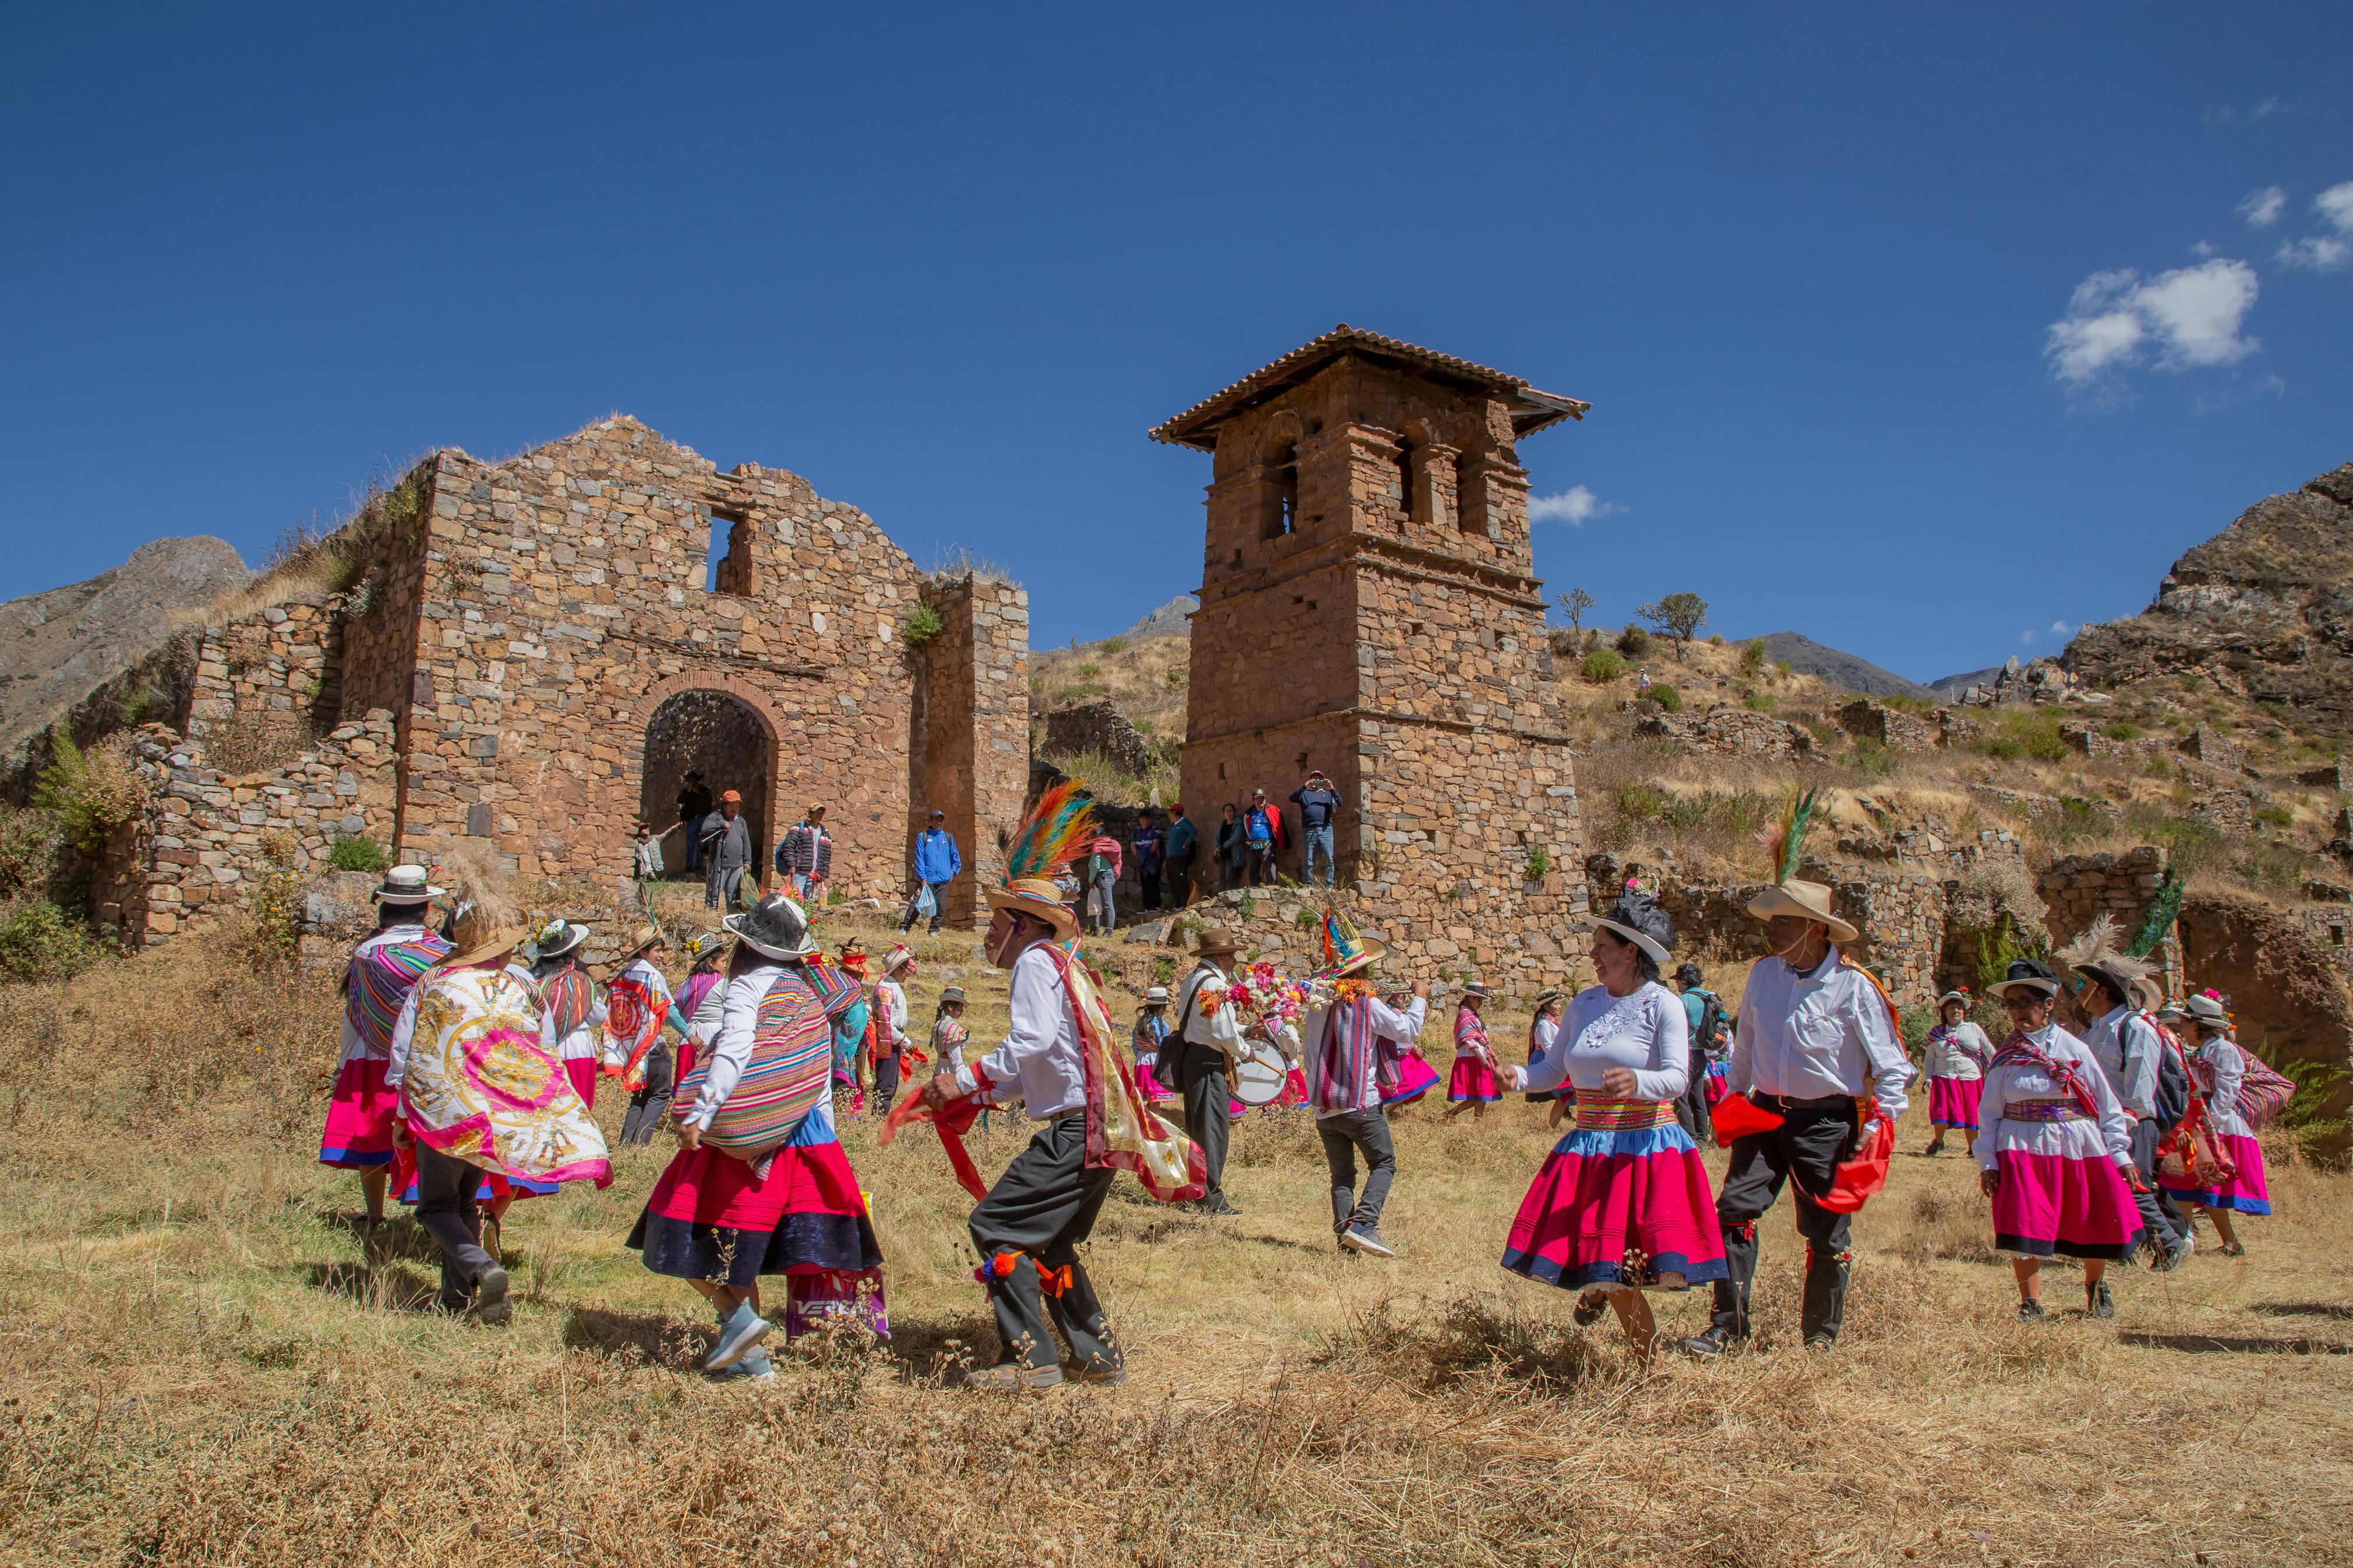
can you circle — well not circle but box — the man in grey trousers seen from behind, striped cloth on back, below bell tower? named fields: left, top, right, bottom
left=1301, top=938, right=1430, bottom=1258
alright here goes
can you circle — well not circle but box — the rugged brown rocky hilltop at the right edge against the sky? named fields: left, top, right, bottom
left=2061, top=463, right=2353, bottom=738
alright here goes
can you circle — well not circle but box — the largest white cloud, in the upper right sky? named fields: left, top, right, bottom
left=2043, top=261, right=2261, bottom=388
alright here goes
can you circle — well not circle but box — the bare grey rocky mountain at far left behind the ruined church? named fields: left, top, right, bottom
left=0, top=539, right=254, bottom=752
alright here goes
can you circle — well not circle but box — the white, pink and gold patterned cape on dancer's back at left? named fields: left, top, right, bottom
left=402, top=968, right=612, bottom=1187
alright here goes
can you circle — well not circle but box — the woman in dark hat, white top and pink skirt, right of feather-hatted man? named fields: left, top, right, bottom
left=1977, top=959, right=2141, bottom=1323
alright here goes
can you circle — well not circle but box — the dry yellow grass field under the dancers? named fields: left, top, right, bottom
left=0, top=922, right=2353, bottom=1568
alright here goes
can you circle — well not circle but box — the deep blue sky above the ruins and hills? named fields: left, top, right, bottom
left=0, top=2, right=2353, bottom=677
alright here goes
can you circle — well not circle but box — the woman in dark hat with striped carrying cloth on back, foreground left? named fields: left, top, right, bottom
left=628, top=893, right=889, bottom=1380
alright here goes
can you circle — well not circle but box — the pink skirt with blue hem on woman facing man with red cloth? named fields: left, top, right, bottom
left=1504, top=1095, right=1729, bottom=1291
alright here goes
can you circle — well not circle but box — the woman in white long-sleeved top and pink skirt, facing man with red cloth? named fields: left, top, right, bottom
left=1504, top=891, right=1727, bottom=1357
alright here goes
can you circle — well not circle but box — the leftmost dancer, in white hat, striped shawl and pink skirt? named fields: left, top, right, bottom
left=317, top=865, right=450, bottom=1227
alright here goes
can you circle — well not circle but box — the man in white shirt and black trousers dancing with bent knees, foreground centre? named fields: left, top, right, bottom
left=923, top=877, right=1127, bottom=1389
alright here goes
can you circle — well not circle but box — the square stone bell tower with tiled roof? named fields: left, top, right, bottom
left=1151, top=324, right=1588, bottom=990
